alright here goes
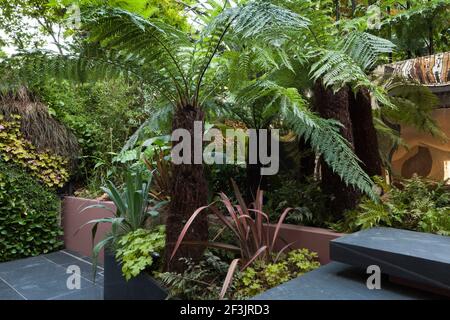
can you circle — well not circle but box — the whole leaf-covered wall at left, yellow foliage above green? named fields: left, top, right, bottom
left=0, top=114, right=69, bottom=262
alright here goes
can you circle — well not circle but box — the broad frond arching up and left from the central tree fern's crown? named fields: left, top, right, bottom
left=85, top=8, right=192, bottom=98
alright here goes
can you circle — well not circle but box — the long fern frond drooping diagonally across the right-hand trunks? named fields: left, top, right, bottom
left=235, top=80, right=378, bottom=199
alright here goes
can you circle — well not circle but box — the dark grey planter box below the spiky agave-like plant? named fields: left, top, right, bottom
left=103, top=252, right=168, bottom=300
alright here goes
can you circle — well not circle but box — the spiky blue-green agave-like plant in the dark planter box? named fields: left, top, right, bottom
left=79, top=166, right=167, bottom=270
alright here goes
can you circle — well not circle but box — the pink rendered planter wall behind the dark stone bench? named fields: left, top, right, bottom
left=269, top=224, right=344, bottom=264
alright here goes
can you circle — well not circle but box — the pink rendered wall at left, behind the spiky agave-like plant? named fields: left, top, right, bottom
left=62, top=197, right=115, bottom=263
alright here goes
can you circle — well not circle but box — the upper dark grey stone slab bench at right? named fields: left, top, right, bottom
left=330, top=228, right=450, bottom=292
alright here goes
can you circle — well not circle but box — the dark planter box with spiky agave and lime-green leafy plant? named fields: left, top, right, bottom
left=84, top=167, right=167, bottom=300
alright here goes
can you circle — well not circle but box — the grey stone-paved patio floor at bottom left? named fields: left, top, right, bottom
left=0, top=250, right=103, bottom=300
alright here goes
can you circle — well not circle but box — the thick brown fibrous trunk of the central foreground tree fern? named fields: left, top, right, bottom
left=165, top=106, right=208, bottom=272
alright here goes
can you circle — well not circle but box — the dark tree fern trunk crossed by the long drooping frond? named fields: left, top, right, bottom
left=314, top=83, right=360, bottom=219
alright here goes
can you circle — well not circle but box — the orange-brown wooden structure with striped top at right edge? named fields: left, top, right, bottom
left=382, top=52, right=450, bottom=184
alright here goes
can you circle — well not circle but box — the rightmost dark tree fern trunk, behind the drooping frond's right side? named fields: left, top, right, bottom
left=349, top=89, right=382, bottom=177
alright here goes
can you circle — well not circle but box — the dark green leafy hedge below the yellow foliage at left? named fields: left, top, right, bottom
left=0, top=160, right=62, bottom=262
